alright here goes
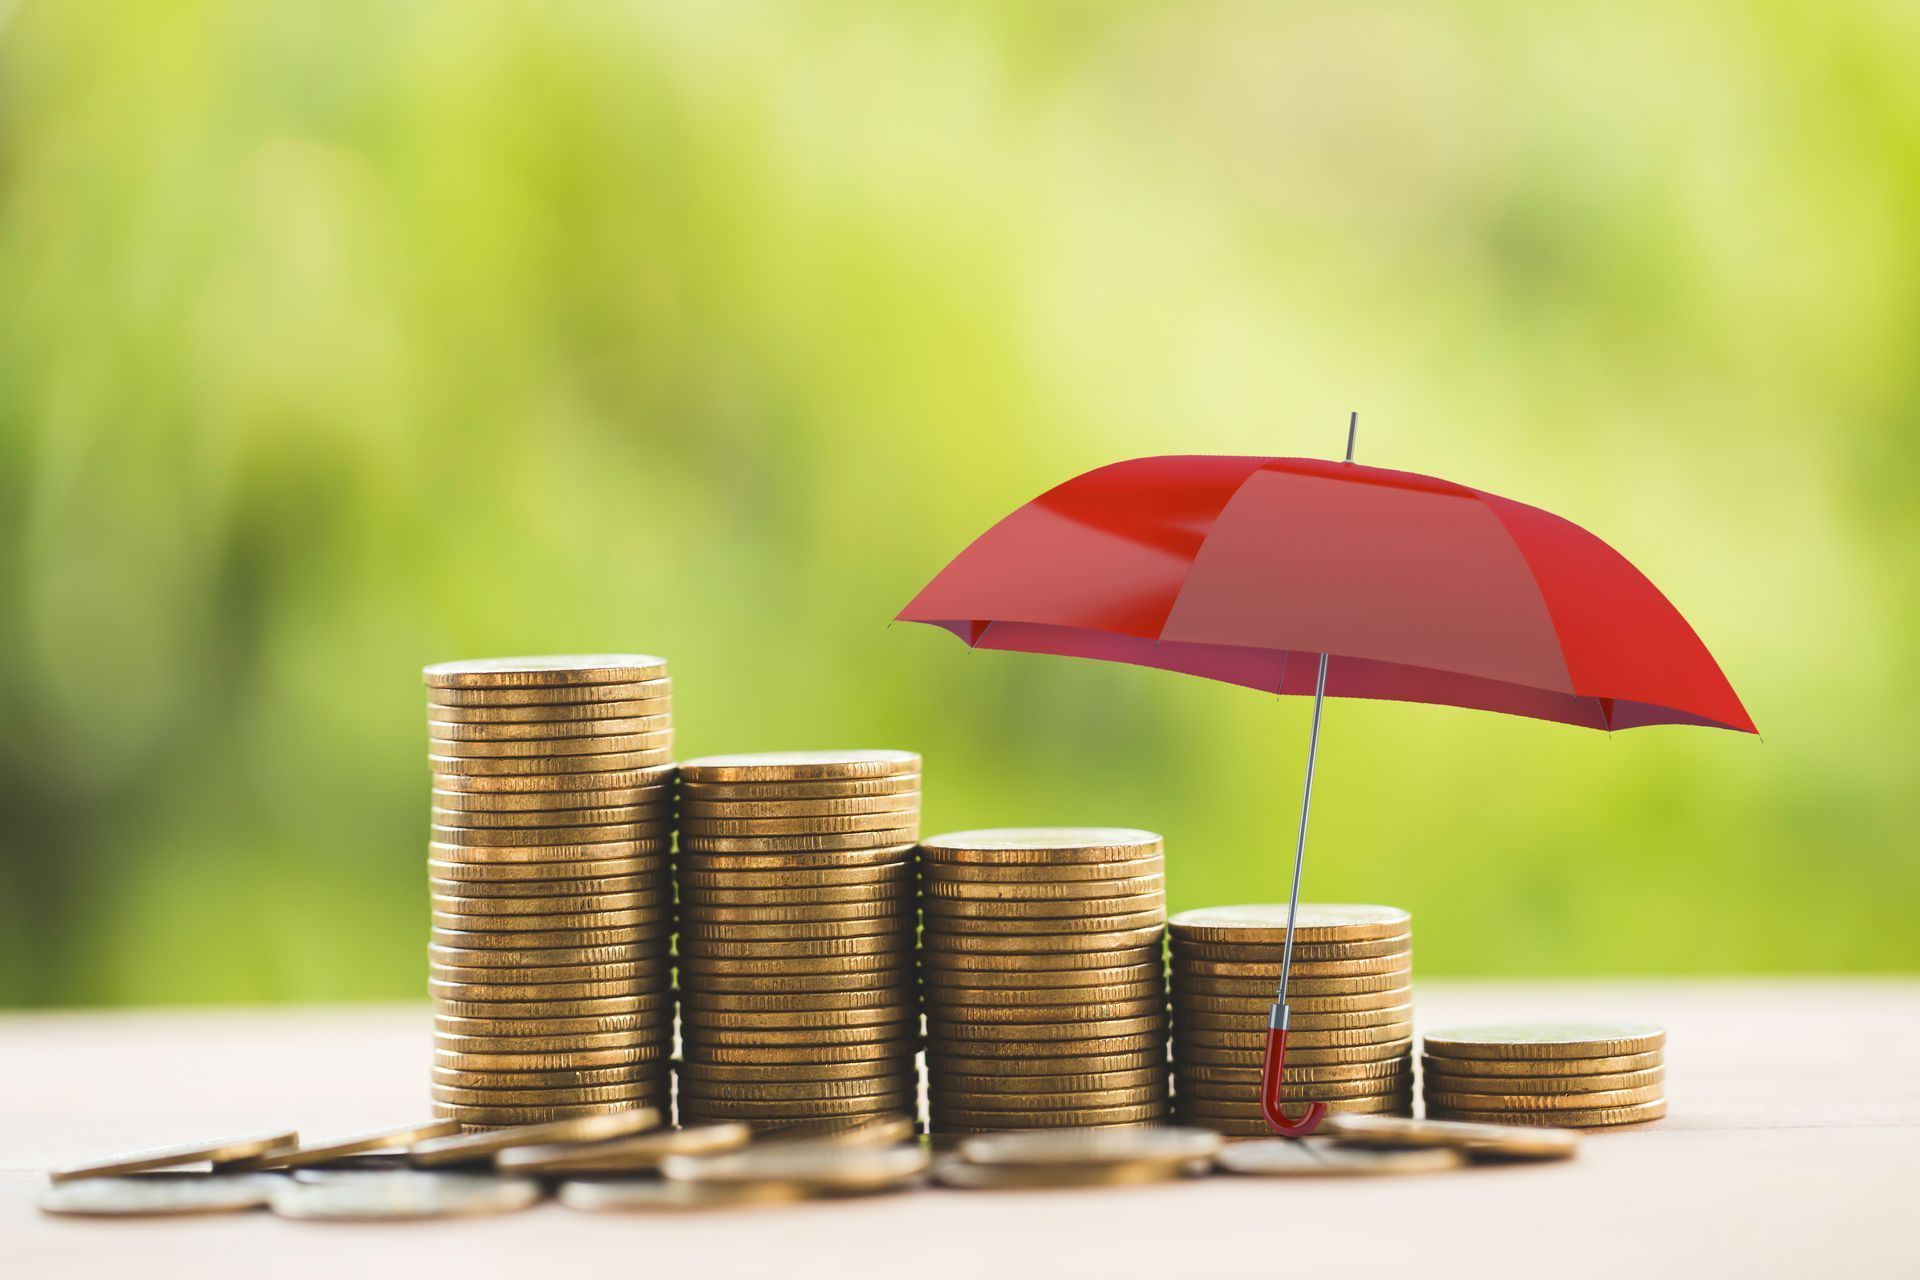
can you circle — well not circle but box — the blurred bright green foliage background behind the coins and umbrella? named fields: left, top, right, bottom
left=0, top=0, right=1920, bottom=1006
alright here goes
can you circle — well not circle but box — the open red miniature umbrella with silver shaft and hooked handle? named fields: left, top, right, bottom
left=899, top=422, right=1755, bottom=1136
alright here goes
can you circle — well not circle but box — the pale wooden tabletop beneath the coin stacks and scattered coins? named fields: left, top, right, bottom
left=0, top=981, right=1920, bottom=1280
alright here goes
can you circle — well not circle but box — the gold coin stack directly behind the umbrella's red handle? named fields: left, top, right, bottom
left=1167, top=902, right=1413, bottom=1136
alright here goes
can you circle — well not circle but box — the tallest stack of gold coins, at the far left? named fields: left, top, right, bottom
left=426, top=654, right=674, bottom=1128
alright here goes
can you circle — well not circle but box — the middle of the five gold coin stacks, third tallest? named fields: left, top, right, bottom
left=920, top=827, right=1167, bottom=1134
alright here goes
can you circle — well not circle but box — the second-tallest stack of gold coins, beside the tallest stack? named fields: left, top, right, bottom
left=674, top=750, right=920, bottom=1128
